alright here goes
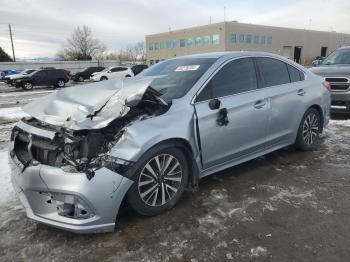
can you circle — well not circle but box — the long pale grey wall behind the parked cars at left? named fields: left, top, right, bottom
left=0, top=60, right=120, bottom=73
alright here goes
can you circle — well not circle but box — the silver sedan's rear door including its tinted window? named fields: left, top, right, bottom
left=256, top=57, right=306, bottom=146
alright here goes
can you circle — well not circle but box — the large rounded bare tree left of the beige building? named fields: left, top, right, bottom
left=57, top=25, right=106, bottom=60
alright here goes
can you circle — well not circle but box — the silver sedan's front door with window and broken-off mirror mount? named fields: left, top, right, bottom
left=195, top=58, right=269, bottom=169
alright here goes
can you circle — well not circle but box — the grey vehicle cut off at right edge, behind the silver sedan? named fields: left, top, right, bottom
left=311, top=46, right=350, bottom=114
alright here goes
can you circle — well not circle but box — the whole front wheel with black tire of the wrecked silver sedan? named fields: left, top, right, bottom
left=127, top=148, right=189, bottom=216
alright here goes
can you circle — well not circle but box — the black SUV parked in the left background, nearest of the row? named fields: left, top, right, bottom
left=16, top=69, right=69, bottom=90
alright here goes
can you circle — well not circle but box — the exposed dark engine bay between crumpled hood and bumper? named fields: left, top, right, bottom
left=11, top=87, right=169, bottom=179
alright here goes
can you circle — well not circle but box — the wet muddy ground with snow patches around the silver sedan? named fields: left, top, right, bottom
left=0, top=81, right=350, bottom=262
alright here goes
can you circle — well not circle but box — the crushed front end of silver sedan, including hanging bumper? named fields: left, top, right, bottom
left=9, top=78, right=167, bottom=233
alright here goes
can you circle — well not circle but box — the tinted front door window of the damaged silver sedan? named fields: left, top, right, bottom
left=197, top=58, right=257, bottom=101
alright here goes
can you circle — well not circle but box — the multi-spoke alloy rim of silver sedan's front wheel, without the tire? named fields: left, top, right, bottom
left=137, top=154, right=183, bottom=207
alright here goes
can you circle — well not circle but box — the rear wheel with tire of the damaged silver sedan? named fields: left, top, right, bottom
left=295, top=108, right=322, bottom=151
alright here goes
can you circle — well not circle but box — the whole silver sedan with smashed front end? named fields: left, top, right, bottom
left=9, top=52, right=330, bottom=233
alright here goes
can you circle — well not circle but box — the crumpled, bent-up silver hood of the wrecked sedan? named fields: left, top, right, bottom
left=23, top=77, right=154, bottom=130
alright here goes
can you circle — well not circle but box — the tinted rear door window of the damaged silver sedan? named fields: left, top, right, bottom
left=257, top=58, right=290, bottom=87
